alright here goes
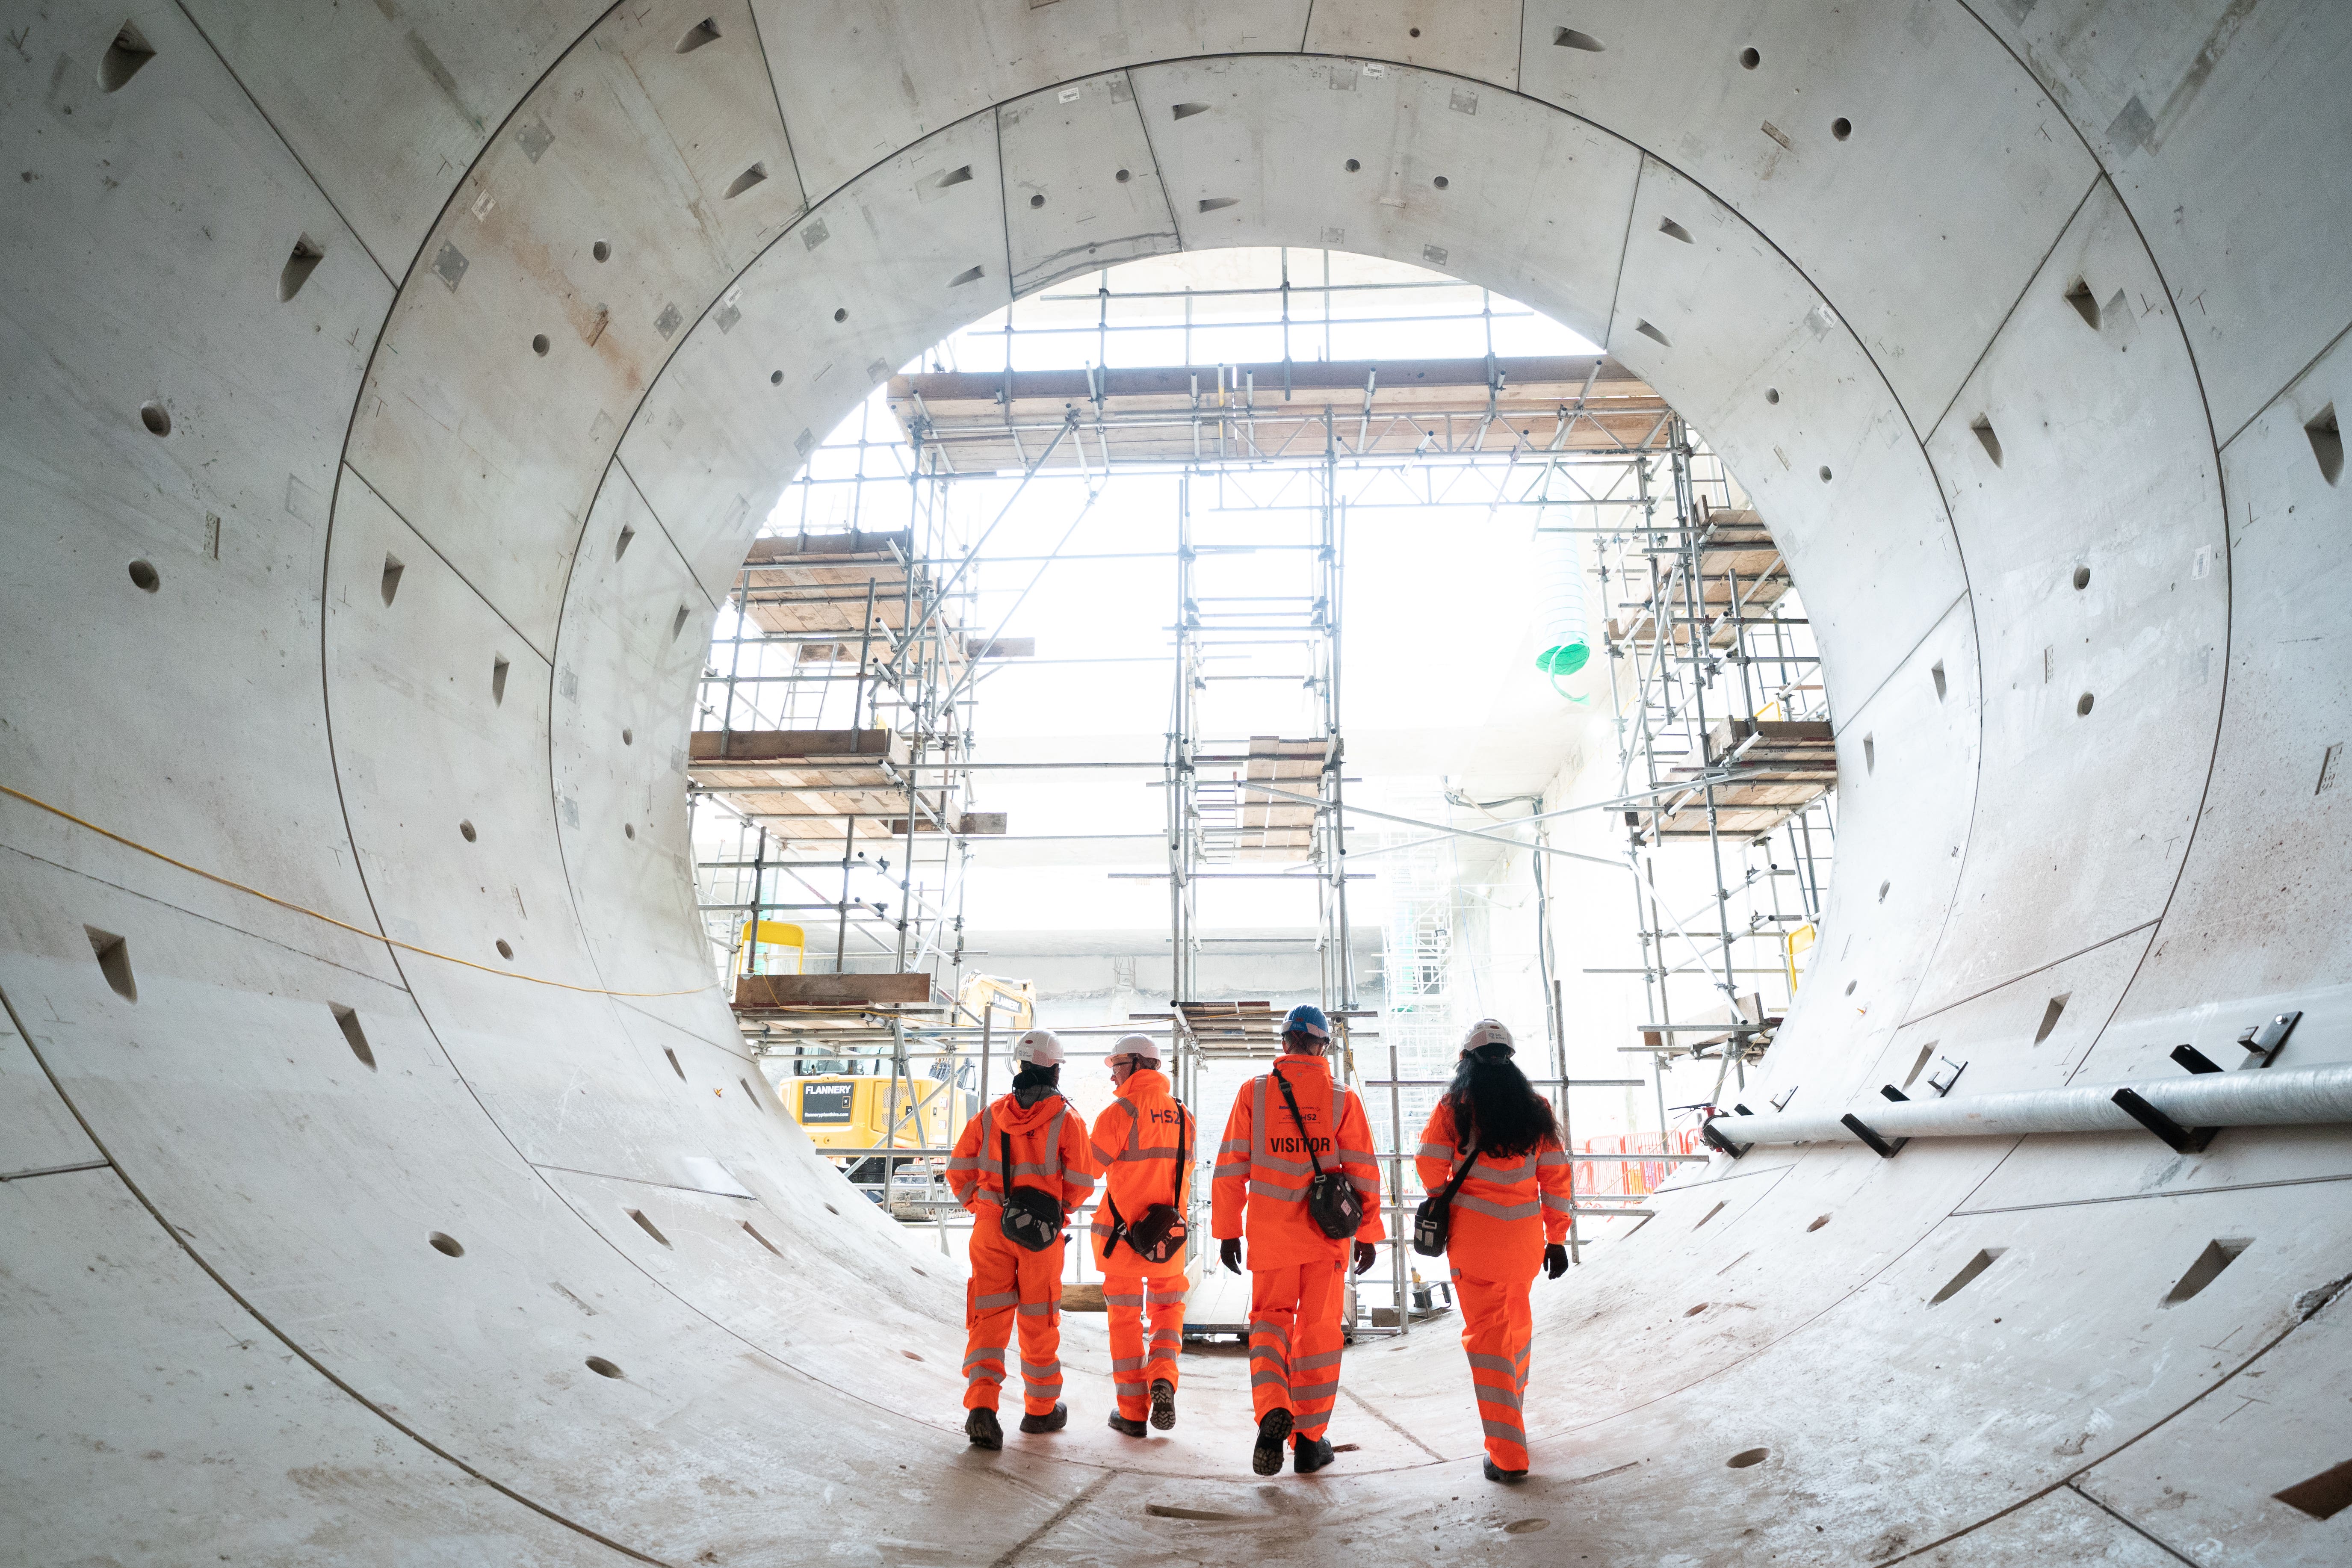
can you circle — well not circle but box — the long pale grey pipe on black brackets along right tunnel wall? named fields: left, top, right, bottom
left=1708, top=1063, right=2352, bottom=1145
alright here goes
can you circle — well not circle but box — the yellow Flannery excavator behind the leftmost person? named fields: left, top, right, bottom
left=762, top=969, right=1037, bottom=1204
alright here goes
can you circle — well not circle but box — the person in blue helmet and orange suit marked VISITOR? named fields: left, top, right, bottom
left=1209, top=1006, right=1388, bottom=1476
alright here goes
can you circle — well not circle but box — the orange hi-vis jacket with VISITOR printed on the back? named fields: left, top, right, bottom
left=1209, top=1053, right=1388, bottom=1270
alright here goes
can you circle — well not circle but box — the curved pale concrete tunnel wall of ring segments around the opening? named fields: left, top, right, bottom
left=0, top=0, right=2352, bottom=1563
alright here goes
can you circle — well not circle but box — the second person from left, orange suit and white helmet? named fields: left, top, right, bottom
left=1094, top=1034, right=1200, bottom=1436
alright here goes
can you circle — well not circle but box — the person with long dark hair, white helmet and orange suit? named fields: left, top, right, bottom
left=1414, top=1018, right=1569, bottom=1481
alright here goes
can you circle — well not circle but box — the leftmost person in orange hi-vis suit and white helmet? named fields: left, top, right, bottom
left=948, top=1030, right=1094, bottom=1448
